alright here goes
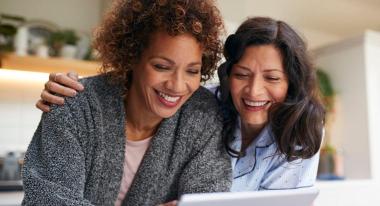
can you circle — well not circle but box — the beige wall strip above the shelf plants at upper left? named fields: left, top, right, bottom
left=0, top=0, right=104, bottom=33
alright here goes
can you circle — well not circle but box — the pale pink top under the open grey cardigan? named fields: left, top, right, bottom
left=115, top=137, right=152, bottom=206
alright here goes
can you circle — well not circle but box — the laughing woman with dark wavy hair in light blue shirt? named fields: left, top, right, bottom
left=216, top=17, right=324, bottom=191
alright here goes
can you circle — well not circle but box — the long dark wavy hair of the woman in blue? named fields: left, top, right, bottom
left=218, top=17, right=325, bottom=161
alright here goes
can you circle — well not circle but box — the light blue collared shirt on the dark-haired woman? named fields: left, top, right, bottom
left=231, top=119, right=319, bottom=192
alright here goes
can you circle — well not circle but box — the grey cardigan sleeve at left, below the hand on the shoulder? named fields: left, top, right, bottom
left=22, top=97, right=92, bottom=205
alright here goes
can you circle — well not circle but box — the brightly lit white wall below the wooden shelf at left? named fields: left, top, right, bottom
left=0, top=69, right=48, bottom=155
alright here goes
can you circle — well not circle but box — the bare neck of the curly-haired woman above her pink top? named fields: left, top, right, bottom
left=124, top=89, right=162, bottom=141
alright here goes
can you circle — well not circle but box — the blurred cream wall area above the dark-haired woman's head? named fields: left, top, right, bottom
left=217, top=0, right=380, bottom=49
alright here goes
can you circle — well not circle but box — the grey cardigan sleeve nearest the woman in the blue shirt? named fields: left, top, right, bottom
left=178, top=88, right=232, bottom=195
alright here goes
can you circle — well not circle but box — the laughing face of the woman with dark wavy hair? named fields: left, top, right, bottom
left=229, top=45, right=288, bottom=128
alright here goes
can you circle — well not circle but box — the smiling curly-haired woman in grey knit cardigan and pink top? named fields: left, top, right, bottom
left=23, top=0, right=231, bottom=205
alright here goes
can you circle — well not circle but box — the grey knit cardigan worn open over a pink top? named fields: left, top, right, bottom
left=22, top=75, right=231, bottom=206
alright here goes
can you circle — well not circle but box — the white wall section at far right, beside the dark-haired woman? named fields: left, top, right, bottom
left=315, top=32, right=380, bottom=179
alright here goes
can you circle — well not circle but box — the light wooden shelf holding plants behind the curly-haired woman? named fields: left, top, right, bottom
left=0, top=53, right=101, bottom=76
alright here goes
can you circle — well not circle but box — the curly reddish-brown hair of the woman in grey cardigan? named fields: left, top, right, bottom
left=94, top=0, right=224, bottom=89
